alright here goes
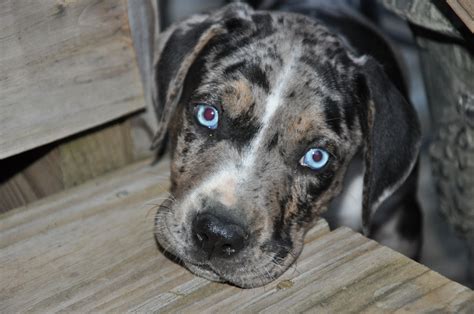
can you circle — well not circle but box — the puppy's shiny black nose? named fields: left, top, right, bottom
left=193, top=214, right=247, bottom=258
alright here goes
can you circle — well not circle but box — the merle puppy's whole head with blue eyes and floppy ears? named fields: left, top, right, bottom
left=148, top=4, right=419, bottom=287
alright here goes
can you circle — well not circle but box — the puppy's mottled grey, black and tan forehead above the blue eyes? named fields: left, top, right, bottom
left=190, top=13, right=356, bottom=144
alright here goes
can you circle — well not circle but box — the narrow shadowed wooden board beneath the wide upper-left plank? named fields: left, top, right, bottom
left=0, top=119, right=136, bottom=212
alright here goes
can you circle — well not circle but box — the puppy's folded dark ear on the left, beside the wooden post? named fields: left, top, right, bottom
left=152, top=3, right=252, bottom=149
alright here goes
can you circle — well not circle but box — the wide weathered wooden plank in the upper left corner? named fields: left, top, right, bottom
left=0, top=0, right=144, bottom=159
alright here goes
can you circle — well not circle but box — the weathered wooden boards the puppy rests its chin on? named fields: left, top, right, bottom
left=0, top=161, right=474, bottom=313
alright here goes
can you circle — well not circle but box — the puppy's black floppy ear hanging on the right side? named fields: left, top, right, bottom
left=357, top=57, right=421, bottom=234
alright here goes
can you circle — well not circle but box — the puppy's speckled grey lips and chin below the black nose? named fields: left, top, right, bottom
left=155, top=201, right=299, bottom=288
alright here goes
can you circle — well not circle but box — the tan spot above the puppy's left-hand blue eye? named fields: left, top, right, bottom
left=222, top=80, right=255, bottom=118
